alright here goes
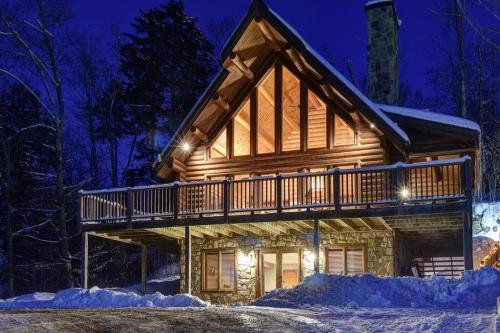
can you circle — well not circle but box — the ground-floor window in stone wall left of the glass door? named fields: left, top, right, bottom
left=202, top=250, right=236, bottom=291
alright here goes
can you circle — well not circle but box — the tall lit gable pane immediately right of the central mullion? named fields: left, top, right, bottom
left=281, top=67, right=300, bottom=151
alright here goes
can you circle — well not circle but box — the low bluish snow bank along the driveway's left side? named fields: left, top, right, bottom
left=0, top=287, right=208, bottom=310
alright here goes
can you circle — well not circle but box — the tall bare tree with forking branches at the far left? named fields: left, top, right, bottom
left=0, top=0, right=73, bottom=287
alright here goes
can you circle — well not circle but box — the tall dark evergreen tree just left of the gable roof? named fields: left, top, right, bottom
left=120, top=0, right=216, bottom=184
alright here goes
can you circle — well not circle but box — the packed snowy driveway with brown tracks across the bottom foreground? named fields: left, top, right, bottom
left=0, top=306, right=496, bottom=333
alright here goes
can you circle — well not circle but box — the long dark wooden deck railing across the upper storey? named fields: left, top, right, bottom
left=80, top=157, right=472, bottom=231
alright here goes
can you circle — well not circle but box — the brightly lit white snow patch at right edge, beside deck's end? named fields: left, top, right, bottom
left=474, top=202, right=500, bottom=241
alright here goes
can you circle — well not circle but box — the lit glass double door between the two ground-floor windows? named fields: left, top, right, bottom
left=259, top=250, right=300, bottom=295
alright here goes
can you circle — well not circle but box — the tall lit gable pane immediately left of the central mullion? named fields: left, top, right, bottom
left=257, top=68, right=275, bottom=154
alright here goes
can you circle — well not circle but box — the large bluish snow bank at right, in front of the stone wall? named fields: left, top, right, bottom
left=252, top=266, right=500, bottom=308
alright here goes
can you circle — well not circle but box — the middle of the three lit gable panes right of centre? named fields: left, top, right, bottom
left=307, top=90, right=326, bottom=149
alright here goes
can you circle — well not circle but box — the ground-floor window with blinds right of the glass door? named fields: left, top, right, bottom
left=326, top=245, right=365, bottom=275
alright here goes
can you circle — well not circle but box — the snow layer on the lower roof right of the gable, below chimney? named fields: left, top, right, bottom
left=378, top=104, right=481, bottom=132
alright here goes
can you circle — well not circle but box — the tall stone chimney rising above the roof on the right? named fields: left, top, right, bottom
left=365, top=0, right=400, bottom=105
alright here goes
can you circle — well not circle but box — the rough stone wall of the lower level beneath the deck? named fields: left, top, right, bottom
left=181, top=231, right=394, bottom=304
